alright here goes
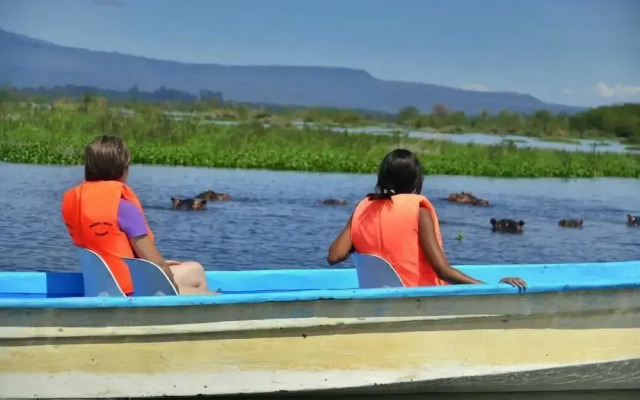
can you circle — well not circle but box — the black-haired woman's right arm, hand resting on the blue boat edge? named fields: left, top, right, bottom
left=418, top=208, right=527, bottom=288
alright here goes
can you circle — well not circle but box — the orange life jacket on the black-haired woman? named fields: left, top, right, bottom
left=351, top=194, right=448, bottom=286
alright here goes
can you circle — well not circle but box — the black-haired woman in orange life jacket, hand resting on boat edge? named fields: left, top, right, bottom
left=327, top=149, right=526, bottom=289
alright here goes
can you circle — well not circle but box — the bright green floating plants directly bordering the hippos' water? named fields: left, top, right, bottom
left=0, top=110, right=640, bottom=178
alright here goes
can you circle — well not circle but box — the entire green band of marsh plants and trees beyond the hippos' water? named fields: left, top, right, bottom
left=0, top=85, right=640, bottom=178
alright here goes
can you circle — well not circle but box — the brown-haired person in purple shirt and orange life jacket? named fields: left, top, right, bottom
left=62, top=135, right=216, bottom=296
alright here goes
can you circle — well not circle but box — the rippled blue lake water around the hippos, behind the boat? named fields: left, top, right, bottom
left=0, top=163, right=640, bottom=270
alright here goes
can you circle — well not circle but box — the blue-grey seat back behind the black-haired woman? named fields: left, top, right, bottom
left=352, top=252, right=404, bottom=289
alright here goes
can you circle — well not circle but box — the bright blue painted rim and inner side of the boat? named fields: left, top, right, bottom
left=0, top=260, right=640, bottom=309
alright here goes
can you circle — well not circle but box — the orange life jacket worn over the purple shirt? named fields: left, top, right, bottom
left=62, top=181, right=153, bottom=294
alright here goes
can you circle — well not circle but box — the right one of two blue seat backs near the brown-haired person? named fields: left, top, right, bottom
left=123, top=257, right=178, bottom=297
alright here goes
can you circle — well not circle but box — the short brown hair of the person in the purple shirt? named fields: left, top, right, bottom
left=84, top=135, right=131, bottom=181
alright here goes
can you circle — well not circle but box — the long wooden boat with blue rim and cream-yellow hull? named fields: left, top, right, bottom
left=0, top=261, right=640, bottom=398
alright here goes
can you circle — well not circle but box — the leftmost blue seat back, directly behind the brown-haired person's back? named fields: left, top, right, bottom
left=76, top=246, right=126, bottom=297
